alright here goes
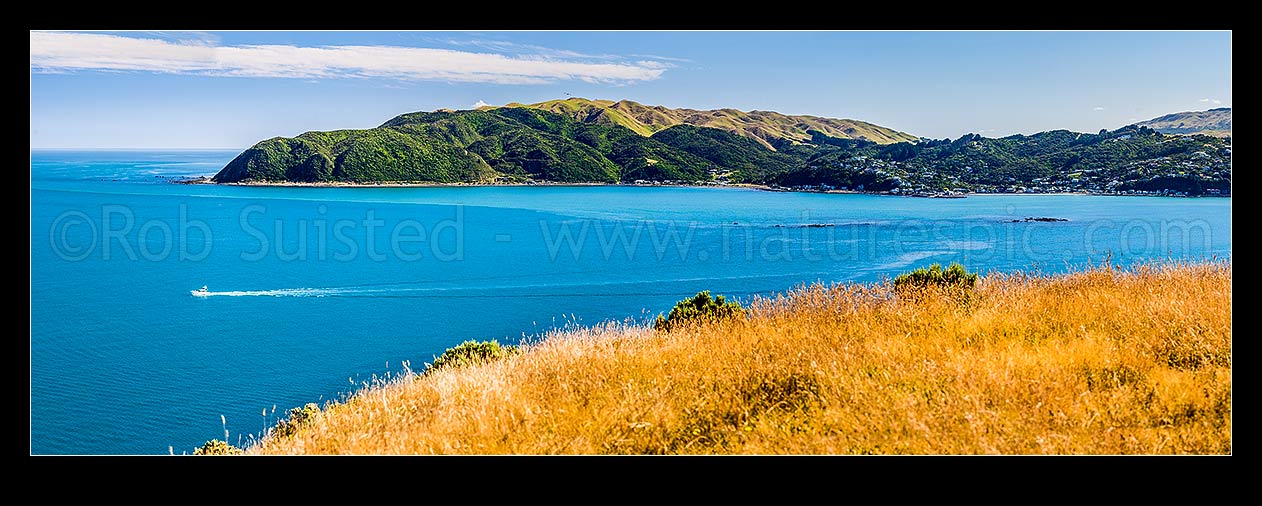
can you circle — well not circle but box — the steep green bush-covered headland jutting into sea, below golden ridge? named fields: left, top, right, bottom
left=213, top=107, right=713, bottom=183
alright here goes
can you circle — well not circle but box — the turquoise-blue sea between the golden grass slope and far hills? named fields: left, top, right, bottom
left=30, top=151, right=1232, bottom=454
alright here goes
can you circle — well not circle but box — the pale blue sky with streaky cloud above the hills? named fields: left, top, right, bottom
left=30, top=30, right=1232, bottom=149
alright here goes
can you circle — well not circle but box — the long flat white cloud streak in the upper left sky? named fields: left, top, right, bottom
left=30, top=32, right=665, bottom=85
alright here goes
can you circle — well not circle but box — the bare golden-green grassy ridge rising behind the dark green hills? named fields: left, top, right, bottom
left=506, top=97, right=916, bottom=150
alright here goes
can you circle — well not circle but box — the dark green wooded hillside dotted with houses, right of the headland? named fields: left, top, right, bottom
left=775, top=126, right=1232, bottom=194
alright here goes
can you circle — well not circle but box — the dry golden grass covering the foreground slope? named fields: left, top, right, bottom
left=247, top=262, right=1232, bottom=454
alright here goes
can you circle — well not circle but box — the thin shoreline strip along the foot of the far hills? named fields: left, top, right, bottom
left=170, top=177, right=1232, bottom=199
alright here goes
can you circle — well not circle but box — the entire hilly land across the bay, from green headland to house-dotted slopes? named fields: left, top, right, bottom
left=213, top=98, right=1232, bottom=196
